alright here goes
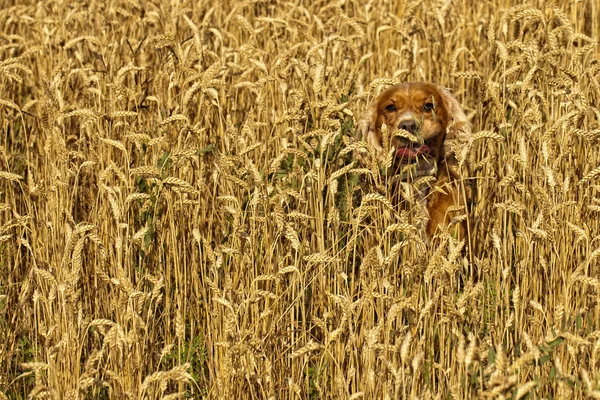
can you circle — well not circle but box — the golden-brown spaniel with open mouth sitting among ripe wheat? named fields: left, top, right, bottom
left=358, top=82, right=471, bottom=239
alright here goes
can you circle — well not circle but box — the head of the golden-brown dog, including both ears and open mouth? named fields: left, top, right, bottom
left=358, top=82, right=470, bottom=176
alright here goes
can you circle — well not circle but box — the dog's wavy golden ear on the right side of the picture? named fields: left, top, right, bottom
left=439, top=86, right=472, bottom=178
